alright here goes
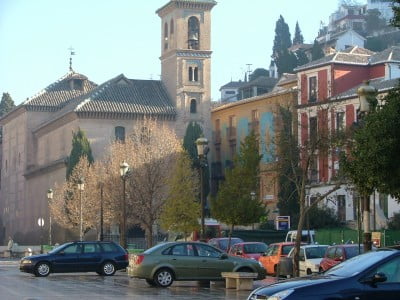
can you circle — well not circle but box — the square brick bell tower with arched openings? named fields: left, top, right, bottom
left=156, top=0, right=217, bottom=138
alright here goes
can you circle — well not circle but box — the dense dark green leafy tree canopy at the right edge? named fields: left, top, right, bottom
left=341, top=87, right=400, bottom=199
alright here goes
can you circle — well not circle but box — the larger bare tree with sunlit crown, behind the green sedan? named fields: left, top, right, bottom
left=107, top=119, right=182, bottom=247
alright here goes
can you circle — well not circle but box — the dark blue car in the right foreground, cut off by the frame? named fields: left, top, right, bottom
left=247, top=249, right=400, bottom=300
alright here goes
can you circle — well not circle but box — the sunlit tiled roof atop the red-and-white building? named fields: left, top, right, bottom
left=294, top=46, right=374, bottom=71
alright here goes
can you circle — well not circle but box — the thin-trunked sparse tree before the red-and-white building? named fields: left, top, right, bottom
left=276, top=103, right=344, bottom=276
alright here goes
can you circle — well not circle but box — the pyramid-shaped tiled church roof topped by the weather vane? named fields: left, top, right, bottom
left=22, top=71, right=97, bottom=111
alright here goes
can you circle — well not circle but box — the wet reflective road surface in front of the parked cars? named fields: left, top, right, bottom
left=0, top=261, right=274, bottom=300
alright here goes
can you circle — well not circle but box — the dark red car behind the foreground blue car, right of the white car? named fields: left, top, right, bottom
left=319, top=244, right=364, bottom=272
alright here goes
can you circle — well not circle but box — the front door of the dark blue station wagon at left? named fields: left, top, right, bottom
left=52, top=243, right=81, bottom=272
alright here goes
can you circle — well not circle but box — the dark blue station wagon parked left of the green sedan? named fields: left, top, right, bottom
left=19, top=241, right=129, bottom=277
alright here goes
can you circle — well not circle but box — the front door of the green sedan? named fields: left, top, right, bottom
left=195, top=244, right=234, bottom=280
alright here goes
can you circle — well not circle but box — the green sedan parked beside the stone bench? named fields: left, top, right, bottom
left=130, top=242, right=266, bottom=287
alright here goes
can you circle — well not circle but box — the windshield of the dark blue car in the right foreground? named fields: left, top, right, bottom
left=324, top=251, right=393, bottom=277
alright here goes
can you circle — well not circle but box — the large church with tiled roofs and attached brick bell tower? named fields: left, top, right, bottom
left=0, top=0, right=216, bottom=243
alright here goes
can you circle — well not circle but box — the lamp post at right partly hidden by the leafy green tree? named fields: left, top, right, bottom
left=357, top=81, right=377, bottom=252
